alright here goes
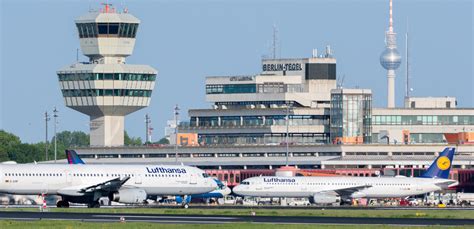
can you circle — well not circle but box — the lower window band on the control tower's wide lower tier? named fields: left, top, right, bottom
left=62, top=89, right=152, bottom=97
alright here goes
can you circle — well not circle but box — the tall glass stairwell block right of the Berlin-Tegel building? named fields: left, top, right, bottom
left=330, top=91, right=372, bottom=143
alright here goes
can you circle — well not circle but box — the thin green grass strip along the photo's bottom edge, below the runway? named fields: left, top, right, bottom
left=0, top=220, right=468, bottom=229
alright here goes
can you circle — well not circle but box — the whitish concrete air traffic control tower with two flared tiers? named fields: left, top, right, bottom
left=57, top=4, right=157, bottom=146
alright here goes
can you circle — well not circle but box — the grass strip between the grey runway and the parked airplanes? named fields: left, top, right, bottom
left=0, top=208, right=474, bottom=219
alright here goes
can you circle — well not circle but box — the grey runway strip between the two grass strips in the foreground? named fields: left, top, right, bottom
left=0, top=211, right=474, bottom=226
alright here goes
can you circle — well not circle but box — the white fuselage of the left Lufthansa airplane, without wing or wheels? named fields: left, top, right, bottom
left=0, top=164, right=216, bottom=196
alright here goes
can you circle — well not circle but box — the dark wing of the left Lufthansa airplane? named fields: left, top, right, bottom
left=58, top=176, right=130, bottom=196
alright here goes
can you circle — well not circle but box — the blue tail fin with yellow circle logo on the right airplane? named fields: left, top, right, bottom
left=421, top=147, right=456, bottom=179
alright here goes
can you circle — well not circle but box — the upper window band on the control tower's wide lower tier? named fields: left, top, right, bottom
left=58, top=73, right=156, bottom=81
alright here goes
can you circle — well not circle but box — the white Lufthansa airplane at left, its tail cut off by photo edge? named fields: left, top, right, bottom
left=0, top=157, right=217, bottom=208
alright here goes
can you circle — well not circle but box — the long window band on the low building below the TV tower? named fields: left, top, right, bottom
left=372, top=115, right=474, bottom=125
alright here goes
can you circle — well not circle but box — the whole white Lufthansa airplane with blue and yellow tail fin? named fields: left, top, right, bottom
left=233, top=148, right=458, bottom=204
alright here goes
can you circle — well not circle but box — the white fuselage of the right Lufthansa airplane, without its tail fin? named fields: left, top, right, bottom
left=233, top=176, right=457, bottom=198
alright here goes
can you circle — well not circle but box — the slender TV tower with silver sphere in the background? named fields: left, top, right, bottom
left=380, top=0, right=402, bottom=108
